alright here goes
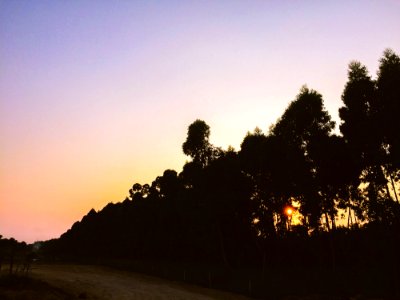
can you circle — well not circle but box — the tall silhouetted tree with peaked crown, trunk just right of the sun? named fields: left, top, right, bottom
left=272, top=86, right=336, bottom=228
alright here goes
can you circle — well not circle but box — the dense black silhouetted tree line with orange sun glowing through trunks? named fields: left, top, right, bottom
left=41, top=50, right=400, bottom=296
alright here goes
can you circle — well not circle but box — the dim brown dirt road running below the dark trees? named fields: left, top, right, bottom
left=32, top=265, right=250, bottom=300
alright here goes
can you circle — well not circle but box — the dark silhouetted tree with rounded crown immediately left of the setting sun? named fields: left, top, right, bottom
left=239, top=128, right=301, bottom=237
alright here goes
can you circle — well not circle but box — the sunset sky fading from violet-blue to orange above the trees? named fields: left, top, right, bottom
left=0, top=0, right=400, bottom=243
